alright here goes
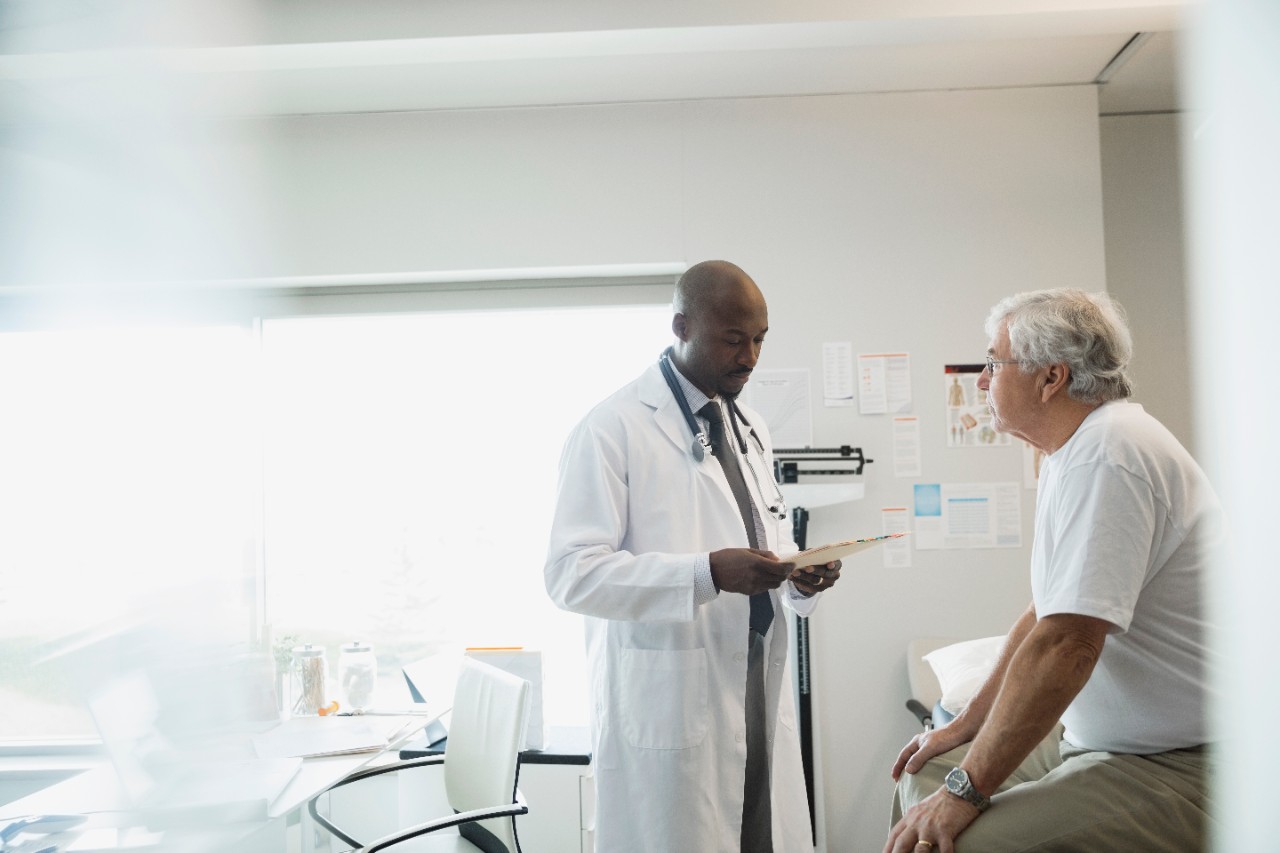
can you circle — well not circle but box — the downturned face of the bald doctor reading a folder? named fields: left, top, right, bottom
left=673, top=284, right=769, bottom=398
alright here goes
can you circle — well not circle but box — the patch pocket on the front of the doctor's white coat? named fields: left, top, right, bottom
left=621, top=648, right=708, bottom=749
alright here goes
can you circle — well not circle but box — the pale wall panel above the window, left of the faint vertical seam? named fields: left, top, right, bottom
left=261, top=105, right=684, bottom=274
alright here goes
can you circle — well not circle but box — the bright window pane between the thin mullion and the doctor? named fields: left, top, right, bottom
left=262, top=306, right=671, bottom=722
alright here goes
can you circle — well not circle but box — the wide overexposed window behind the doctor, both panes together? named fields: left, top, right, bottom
left=0, top=297, right=671, bottom=742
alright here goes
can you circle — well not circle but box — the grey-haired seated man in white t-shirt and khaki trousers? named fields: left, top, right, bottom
left=884, top=289, right=1221, bottom=853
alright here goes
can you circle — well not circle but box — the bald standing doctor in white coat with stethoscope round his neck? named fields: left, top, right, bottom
left=545, top=261, right=840, bottom=853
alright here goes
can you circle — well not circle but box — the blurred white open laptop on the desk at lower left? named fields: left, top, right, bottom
left=88, top=672, right=302, bottom=826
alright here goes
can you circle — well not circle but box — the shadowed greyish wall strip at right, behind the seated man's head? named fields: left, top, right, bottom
left=1100, top=114, right=1196, bottom=453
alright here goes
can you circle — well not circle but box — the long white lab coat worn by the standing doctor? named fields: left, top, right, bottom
left=545, top=365, right=818, bottom=853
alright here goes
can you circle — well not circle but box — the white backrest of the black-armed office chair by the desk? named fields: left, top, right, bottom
left=444, top=658, right=530, bottom=853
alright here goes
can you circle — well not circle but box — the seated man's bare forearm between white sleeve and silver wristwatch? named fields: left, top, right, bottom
left=963, top=615, right=1107, bottom=795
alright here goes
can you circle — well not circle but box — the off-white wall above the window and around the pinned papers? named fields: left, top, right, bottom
left=238, top=81, right=1105, bottom=850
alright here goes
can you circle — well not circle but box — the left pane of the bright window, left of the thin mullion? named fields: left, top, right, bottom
left=0, top=327, right=255, bottom=740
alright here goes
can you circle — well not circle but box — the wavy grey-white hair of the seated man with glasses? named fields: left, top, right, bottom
left=987, top=288, right=1133, bottom=403
